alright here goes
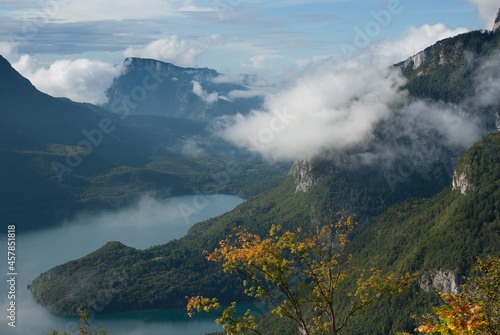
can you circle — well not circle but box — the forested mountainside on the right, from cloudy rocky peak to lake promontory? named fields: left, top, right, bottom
left=24, top=32, right=500, bottom=334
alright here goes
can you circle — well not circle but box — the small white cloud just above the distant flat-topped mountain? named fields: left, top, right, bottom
left=123, top=35, right=219, bottom=67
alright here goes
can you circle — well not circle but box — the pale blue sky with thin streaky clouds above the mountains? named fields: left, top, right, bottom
left=0, top=0, right=500, bottom=74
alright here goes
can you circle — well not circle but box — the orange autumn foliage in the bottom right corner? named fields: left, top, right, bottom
left=402, top=256, right=500, bottom=335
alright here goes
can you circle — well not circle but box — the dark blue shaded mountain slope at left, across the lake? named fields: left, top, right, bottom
left=0, top=56, right=283, bottom=231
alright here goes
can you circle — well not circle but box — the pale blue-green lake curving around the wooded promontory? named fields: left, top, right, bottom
left=0, top=194, right=244, bottom=335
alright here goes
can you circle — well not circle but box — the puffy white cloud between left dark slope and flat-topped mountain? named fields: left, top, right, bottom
left=12, top=55, right=121, bottom=104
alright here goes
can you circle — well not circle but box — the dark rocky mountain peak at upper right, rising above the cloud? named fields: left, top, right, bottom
left=396, top=31, right=500, bottom=117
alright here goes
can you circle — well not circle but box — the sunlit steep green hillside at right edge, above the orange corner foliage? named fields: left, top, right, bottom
left=342, top=132, right=500, bottom=335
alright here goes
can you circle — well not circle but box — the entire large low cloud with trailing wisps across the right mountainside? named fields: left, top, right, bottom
left=219, top=25, right=480, bottom=163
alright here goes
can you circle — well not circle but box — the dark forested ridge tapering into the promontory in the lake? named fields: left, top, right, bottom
left=31, top=151, right=450, bottom=313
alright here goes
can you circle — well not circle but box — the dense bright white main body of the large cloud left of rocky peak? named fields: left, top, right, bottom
left=220, top=64, right=404, bottom=160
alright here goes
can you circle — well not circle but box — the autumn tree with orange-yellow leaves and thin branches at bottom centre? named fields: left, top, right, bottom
left=187, top=215, right=416, bottom=335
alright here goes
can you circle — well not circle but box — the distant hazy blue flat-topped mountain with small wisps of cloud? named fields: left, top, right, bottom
left=102, top=58, right=262, bottom=121
